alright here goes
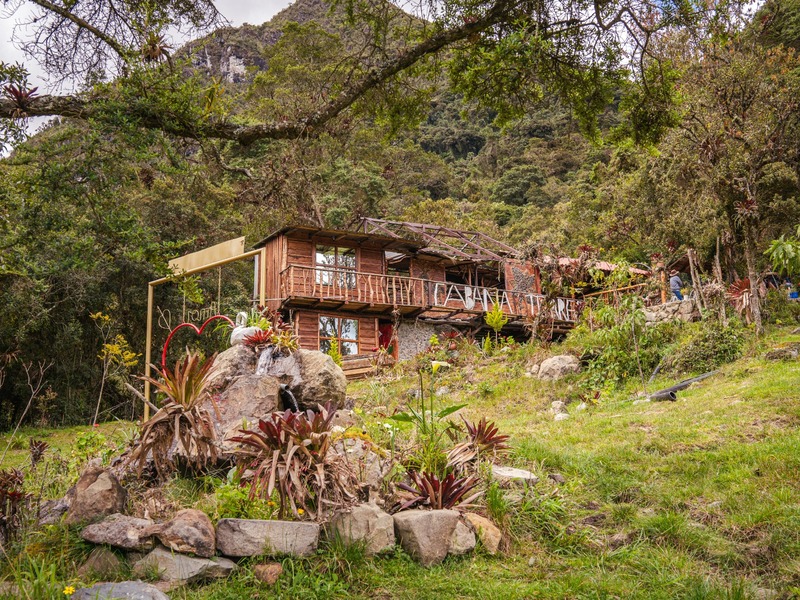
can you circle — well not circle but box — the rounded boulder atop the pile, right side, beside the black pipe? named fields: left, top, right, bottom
left=256, top=348, right=347, bottom=408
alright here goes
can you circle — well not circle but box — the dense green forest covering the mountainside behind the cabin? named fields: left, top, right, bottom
left=0, top=0, right=800, bottom=429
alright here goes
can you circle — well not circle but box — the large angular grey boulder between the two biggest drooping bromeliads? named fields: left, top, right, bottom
left=212, top=374, right=281, bottom=439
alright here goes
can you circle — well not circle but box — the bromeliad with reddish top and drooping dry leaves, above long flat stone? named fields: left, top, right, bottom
left=229, top=403, right=358, bottom=519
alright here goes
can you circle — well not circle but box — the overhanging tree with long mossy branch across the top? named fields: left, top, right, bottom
left=0, top=0, right=698, bottom=150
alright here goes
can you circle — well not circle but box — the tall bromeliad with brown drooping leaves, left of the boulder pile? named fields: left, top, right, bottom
left=128, top=352, right=217, bottom=479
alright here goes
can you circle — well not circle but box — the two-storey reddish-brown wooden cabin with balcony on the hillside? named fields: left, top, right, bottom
left=248, top=219, right=577, bottom=372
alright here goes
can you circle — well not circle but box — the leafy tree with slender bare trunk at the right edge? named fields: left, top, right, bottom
left=666, top=38, right=800, bottom=333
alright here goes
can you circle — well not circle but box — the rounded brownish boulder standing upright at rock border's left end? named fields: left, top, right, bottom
left=66, top=467, right=128, bottom=525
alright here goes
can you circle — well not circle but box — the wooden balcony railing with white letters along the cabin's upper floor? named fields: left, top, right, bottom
left=281, top=265, right=582, bottom=322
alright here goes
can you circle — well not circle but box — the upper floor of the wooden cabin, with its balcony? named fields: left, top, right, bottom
left=256, top=227, right=579, bottom=322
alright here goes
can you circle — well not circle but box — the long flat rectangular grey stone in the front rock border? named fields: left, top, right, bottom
left=217, top=519, right=320, bottom=557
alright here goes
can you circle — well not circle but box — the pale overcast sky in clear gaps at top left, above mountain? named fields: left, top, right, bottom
left=0, top=0, right=291, bottom=91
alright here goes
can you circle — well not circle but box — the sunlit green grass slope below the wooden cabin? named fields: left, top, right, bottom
left=0, top=329, right=800, bottom=599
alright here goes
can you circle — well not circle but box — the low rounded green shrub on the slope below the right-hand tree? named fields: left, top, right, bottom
left=668, top=320, right=747, bottom=373
